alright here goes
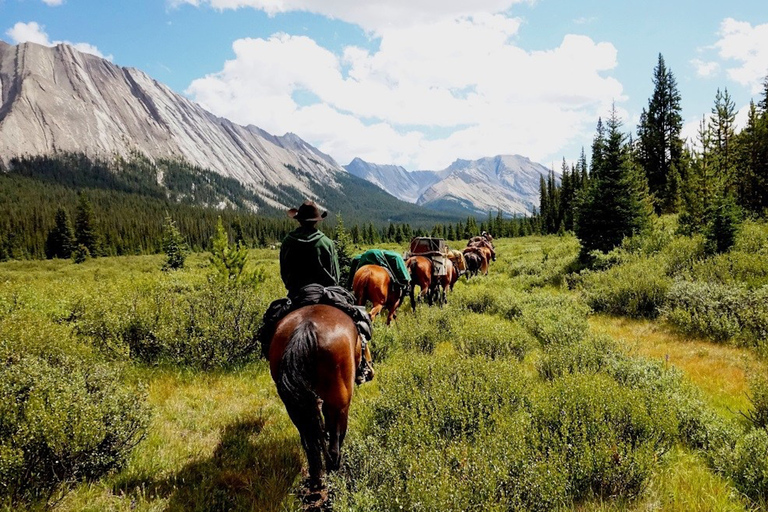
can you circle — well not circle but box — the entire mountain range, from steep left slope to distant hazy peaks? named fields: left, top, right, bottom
left=0, top=41, right=547, bottom=223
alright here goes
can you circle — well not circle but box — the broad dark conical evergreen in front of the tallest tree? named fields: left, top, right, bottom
left=575, top=104, right=652, bottom=257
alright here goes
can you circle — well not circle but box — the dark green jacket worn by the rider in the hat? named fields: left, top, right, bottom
left=280, top=227, right=339, bottom=295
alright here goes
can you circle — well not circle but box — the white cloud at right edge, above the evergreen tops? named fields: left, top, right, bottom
left=714, top=18, right=768, bottom=94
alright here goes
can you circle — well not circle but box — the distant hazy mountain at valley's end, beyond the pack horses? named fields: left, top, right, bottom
left=345, top=155, right=559, bottom=215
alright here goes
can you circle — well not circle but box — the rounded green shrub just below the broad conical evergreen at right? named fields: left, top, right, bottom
left=580, top=259, right=672, bottom=318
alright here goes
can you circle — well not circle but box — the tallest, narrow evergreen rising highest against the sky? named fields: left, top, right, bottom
left=637, top=54, right=683, bottom=212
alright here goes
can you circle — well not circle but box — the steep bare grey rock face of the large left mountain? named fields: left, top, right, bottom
left=0, top=41, right=345, bottom=207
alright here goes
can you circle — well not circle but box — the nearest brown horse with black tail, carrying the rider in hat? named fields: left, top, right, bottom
left=269, top=304, right=370, bottom=489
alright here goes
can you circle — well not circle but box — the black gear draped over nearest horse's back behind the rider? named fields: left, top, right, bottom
left=257, top=284, right=373, bottom=359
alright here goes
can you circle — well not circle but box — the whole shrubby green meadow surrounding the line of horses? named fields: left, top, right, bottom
left=0, top=218, right=768, bottom=511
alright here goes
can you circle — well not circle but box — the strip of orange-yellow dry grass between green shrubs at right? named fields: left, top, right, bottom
left=590, top=315, right=768, bottom=416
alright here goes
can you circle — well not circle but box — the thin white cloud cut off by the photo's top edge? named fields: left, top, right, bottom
left=167, top=0, right=534, bottom=33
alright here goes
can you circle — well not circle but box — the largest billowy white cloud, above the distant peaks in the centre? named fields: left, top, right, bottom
left=186, top=14, right=625, bottom=169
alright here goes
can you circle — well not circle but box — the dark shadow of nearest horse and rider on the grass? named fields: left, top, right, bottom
left=119, top=418, right=302, bottom=512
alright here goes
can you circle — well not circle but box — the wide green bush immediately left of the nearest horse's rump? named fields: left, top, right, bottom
left=73, top=276, right=266, bottom=369
